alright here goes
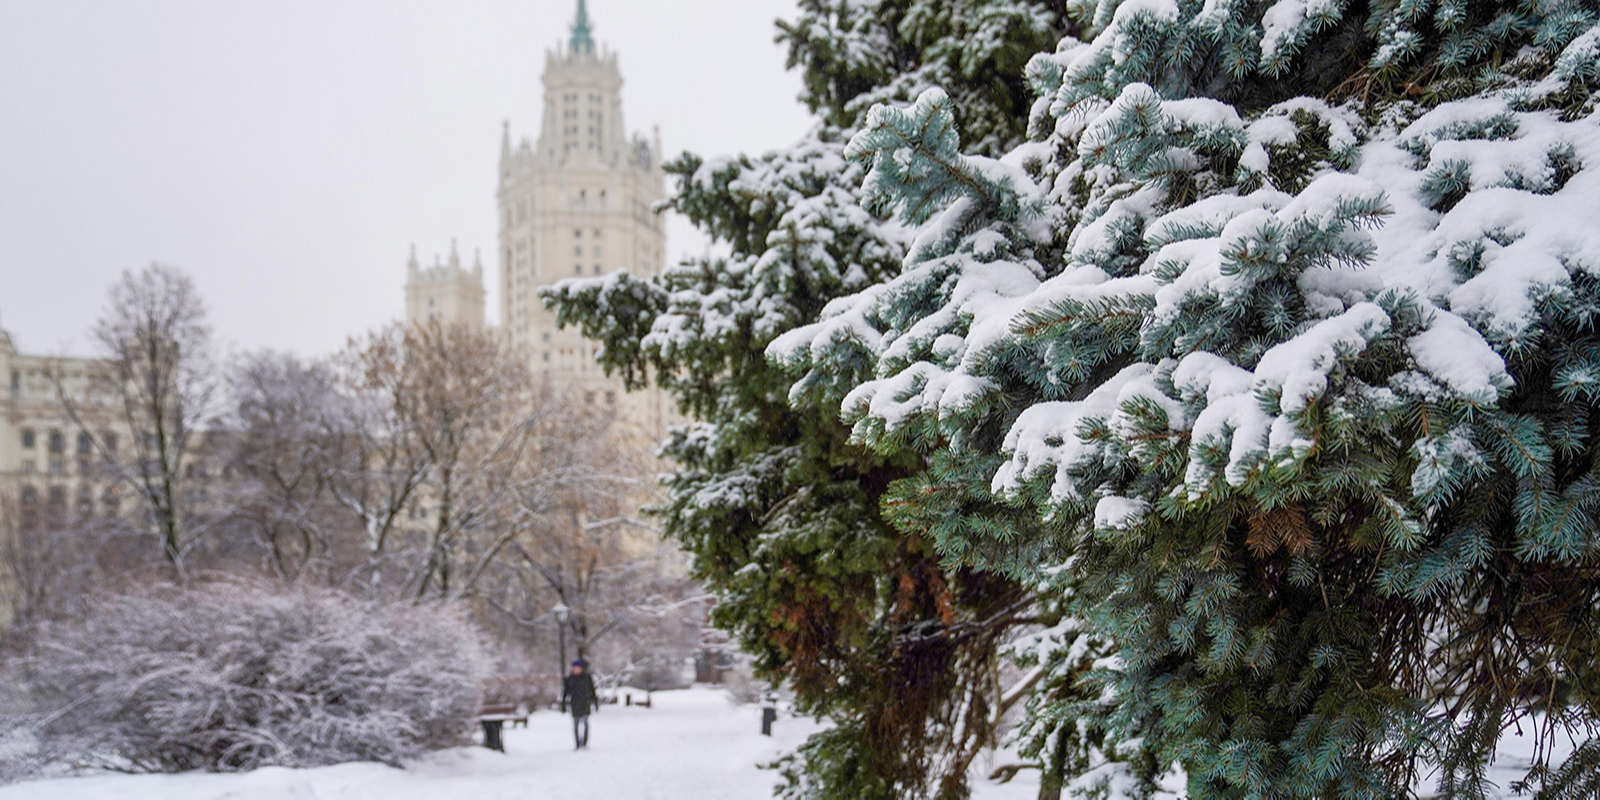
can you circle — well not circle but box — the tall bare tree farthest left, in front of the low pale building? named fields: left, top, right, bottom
left=53, top=264, right=219, bottom=579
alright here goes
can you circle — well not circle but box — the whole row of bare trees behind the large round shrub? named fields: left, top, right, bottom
left=0, top=266, right=704, bottom=777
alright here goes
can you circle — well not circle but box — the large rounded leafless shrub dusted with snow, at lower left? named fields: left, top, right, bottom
left=21, top=584, right=486, bottom=771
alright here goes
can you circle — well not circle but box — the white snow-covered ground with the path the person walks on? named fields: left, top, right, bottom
left=0, top=688, right=1038, bottom=800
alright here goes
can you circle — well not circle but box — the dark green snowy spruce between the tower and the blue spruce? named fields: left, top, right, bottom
left=546, top=0, right=1064, bottom=798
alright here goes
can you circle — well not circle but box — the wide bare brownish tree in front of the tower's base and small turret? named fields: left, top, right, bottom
left=325, top=322, right=637, bottom=600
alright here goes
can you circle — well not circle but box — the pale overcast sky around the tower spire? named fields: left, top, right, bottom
left=0, top=0, right=810, bottom=355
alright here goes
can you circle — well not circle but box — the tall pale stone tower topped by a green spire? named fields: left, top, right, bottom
left=498, top=0, right=667, bottom=440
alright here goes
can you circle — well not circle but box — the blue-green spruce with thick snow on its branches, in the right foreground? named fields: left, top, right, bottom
left=768, top=0, right=1600, bottom=797
